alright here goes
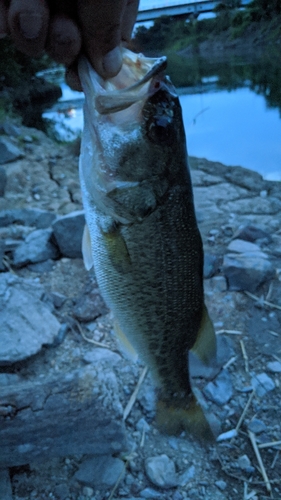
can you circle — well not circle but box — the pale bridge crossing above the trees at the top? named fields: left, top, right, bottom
left=137, top=0, right=251, bottom=22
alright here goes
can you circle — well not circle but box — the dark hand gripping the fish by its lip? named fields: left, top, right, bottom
left=0, top=0, right=139, bottom=87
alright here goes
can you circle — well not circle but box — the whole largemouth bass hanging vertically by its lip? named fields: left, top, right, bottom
left=79, top=49, right=216, bottom=439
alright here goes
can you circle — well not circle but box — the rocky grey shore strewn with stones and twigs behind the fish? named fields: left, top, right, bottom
left=0, top=122, right=281, bottom=500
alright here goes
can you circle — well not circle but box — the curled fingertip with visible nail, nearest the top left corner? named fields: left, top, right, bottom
left=8, top=0, right=49, bottom=56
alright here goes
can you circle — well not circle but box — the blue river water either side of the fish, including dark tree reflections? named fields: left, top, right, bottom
left=40, top=53, right=281, bottom=181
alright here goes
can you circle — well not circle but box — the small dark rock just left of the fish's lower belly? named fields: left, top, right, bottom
left=73, top=280, right=108, bottom=322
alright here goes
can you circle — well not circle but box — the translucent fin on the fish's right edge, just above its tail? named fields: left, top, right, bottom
left=191, top=305, right=217, bottom=365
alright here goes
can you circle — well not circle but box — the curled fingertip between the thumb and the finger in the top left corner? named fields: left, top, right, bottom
left=47, top=14, right=82, bottom=66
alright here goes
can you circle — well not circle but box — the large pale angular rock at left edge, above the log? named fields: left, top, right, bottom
left=0, top=273, right=60, bottom=365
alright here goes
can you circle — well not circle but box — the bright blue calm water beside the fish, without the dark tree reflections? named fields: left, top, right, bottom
left=43, top=61, right=281, bottom=180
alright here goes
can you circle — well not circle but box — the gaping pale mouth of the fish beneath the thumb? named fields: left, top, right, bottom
left=79, top=49, right=167, bottom=115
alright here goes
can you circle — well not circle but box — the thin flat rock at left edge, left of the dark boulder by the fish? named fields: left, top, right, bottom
left=0, top=208, right=56, bottom=229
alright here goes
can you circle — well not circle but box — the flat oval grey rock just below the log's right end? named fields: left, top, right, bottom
left=74, top=455, right=125, bottom=489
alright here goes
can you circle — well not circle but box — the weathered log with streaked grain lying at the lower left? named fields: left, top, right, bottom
left=0, top=366, right=127, bottom=467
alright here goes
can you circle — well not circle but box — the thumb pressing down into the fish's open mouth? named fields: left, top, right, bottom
left=77, top=0, right=127, bottom=78
